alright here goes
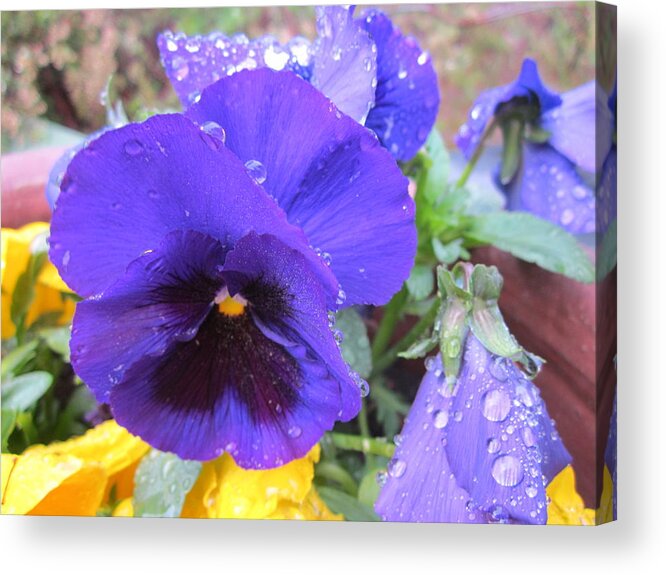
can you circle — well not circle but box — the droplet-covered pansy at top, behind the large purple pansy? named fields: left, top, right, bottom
left=157, top=6, right=439, bottom=161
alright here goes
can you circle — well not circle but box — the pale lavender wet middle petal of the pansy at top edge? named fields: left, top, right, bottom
left=311, top=6, right=377, bottom=124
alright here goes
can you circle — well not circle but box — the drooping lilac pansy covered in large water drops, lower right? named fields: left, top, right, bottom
left=375, top=342, right=571, bottom=524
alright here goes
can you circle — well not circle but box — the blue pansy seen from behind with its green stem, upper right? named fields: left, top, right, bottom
left=456, top=58, right=610, bottom=234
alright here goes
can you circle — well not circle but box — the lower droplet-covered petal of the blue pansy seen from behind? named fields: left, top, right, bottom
left=496, top=142, right=595, bottom=234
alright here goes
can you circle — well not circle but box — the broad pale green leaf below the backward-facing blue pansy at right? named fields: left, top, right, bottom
left=465, top=212, right=594, bottom=283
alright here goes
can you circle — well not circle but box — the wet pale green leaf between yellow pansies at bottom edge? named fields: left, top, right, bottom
left=134, top=449, right=201, bottom=517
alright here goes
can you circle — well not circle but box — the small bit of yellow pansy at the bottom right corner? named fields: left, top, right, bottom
left=546, top=465, right=613, bottom=525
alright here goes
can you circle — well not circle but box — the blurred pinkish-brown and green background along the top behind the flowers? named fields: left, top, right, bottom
left=2, top=2, right=594, bottom=153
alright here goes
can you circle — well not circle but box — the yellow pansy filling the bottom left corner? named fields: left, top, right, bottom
left=1, top=421, right=149, bottom=515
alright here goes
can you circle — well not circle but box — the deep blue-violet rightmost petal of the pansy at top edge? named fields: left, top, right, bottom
left=359, top=10, right=439, bottom=161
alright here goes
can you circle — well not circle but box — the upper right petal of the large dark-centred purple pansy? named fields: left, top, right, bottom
left=187, top=69, right=416, bottom=305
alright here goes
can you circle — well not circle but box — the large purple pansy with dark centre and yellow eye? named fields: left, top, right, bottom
left=50, top=69, right=416, bottom=468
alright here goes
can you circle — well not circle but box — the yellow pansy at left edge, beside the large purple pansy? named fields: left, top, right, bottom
left=0, top=222, right=75, bottom=339
